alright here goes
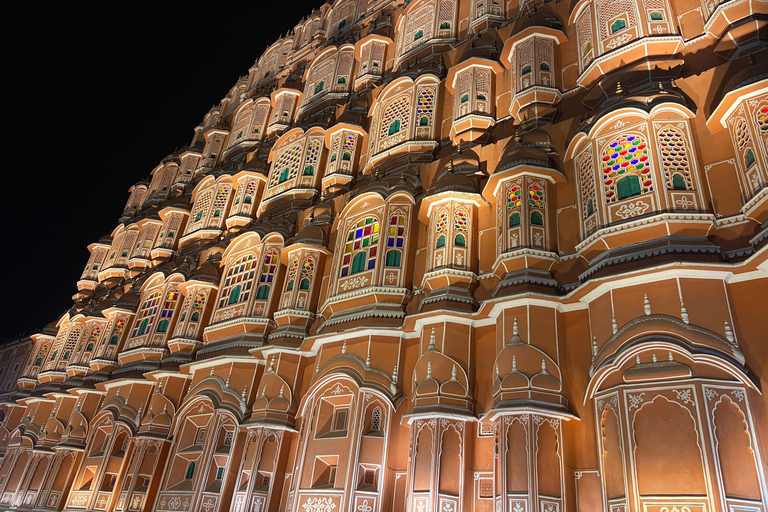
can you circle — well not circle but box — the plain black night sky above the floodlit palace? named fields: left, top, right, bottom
left=0, top=0, right=323, bottom=341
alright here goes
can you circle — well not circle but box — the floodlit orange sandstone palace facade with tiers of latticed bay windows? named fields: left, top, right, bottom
left=0, top=0, right=768, bottom=512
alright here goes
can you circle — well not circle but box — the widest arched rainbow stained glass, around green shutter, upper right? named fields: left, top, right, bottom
left=602, top=134, right=653, bottom=203
